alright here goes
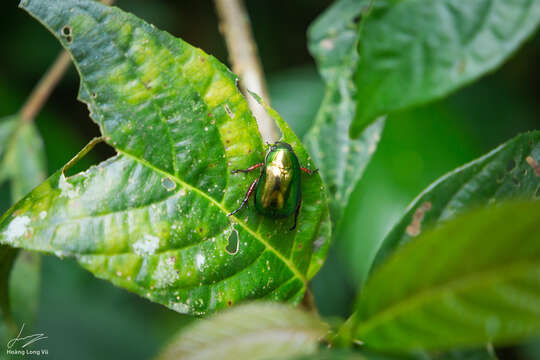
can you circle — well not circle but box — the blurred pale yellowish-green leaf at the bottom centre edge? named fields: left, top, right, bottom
left=154, top=303, right=328, bottom=360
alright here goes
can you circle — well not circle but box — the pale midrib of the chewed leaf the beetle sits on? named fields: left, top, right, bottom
left=116, top=148, right=307, bottom=285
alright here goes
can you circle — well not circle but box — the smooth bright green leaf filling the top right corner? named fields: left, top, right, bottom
left=351, top=0, right=540, bottom=136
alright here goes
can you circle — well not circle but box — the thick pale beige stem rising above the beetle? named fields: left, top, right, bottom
left=215, top=0, right=280, bottom=143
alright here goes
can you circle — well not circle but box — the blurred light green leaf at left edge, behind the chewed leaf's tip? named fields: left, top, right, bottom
left=0, top=116, right=45, bottom=341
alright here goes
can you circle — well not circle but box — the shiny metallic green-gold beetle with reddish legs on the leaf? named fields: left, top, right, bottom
left=228, top=141, right=318, bottom=230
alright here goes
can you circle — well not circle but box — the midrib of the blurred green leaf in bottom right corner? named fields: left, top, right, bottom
left=355, top=259, right=540, bottom=337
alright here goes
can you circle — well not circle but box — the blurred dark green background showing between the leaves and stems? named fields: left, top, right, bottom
left=0, top=0, right=540, bottom=360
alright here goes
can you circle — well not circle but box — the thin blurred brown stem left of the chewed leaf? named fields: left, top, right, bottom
left=20, top=50, right=71, bottom=123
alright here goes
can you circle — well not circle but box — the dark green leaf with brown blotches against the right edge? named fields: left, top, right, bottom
left=374, top=131, right=540, bottom=265
